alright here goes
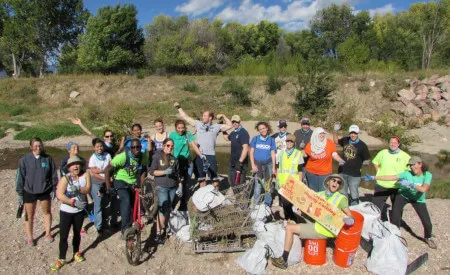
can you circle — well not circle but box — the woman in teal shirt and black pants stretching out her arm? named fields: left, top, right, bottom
left=364, top=156, right=437, bottom=249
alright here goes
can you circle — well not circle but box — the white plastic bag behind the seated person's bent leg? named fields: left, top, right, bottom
left=256, top=223, right=302, bottom=266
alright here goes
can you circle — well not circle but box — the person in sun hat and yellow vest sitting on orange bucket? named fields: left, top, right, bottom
left=272, top=174, right=355, bottom=269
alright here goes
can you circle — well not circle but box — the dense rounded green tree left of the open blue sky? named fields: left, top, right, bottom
left=77, top=4, right=144, bottom=73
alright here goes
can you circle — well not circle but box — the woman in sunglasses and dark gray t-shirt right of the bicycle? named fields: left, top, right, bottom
left=150, top=138, right=183, bottom=243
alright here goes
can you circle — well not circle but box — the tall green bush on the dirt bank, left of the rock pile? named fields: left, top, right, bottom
left=294, top=58, right=336, bottom=117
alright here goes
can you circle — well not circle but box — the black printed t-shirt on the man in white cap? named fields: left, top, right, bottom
left=338, top=137, right=370, bottom=177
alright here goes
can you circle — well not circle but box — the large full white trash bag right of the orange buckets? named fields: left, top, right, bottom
left=366, top=221, right=408, bottom=275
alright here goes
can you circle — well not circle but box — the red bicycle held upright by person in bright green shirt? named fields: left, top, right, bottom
left=125, top=179, right=155, bottom=266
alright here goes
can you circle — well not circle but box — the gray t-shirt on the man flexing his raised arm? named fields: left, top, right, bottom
left=195, top=120, right=220, bottom=156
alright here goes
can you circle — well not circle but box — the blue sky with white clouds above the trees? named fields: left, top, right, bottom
left=84, top=0, right=427, bottom=31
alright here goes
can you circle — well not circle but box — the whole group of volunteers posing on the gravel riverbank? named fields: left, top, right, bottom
left=16, top=103, right=436, bottom=271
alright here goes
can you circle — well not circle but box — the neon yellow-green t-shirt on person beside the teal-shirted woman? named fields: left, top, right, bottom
left=372, top=149, right=410, bottom=188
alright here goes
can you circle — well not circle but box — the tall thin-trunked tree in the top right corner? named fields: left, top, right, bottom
left=410, top=0, right=450, bottom=69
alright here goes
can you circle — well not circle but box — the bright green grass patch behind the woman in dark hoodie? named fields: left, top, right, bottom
left=14, top=123, right=83, bottom=140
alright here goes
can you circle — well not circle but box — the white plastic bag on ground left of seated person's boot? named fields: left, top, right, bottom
left=236, top=240, right=269, bottom=274
